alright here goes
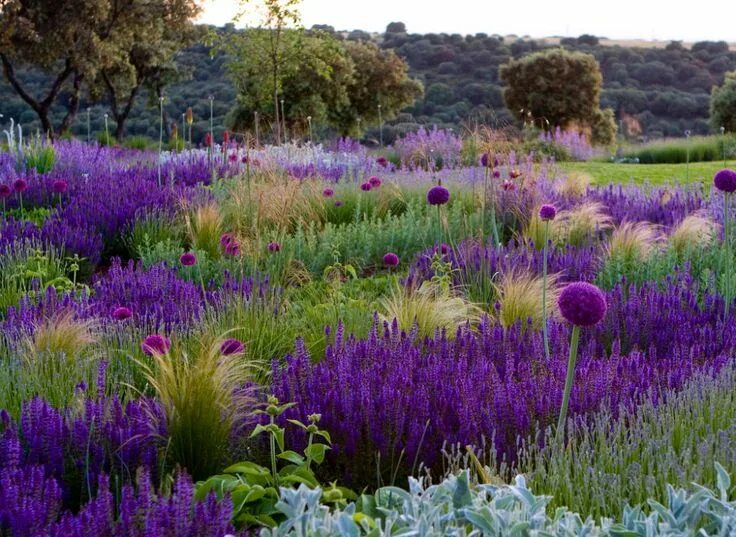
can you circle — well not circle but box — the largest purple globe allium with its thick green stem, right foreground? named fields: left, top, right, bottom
left=557, top=282, right=607, bottom=437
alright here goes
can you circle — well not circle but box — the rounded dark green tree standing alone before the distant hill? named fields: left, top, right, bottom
left=500, top=49, right=616, bottom=143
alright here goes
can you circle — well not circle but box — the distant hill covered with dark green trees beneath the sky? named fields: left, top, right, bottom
left=0, top=27, right=736, bottom=140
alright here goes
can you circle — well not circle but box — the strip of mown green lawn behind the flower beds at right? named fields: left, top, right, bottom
left=559, top=161, right=736, bottom=185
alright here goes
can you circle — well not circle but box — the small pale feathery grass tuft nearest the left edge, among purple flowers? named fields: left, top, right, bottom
left=28, top=310, right=97, bottom=360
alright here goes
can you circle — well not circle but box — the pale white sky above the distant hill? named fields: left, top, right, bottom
left=200, top=0, right=736, bottom=42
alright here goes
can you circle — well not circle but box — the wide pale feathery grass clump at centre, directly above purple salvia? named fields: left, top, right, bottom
left=381, top=282, right=480, bottom=338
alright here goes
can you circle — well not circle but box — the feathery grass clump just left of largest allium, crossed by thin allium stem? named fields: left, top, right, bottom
left=494, top=270, right=559, bottom=328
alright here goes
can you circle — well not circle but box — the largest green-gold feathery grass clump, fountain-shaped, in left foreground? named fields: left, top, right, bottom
left=138, top=338, right=254, bottom=479
